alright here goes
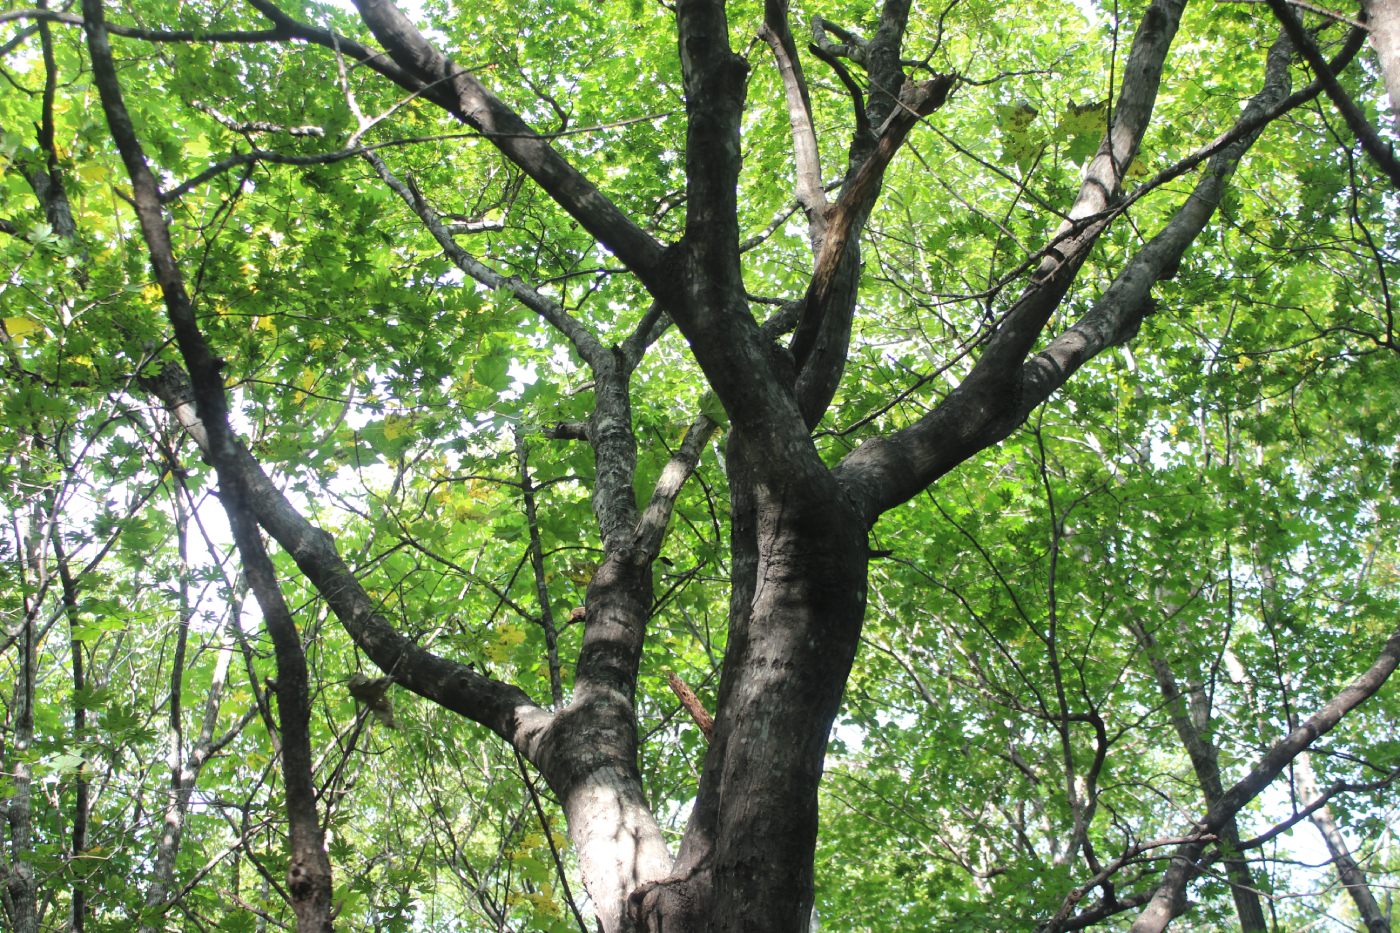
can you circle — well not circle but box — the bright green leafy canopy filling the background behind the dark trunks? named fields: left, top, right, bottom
left=0, top=0, right=1400, bottom=933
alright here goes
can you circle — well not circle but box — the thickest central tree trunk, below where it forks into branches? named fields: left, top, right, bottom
left=631, top=448, right=868, bottom=933
